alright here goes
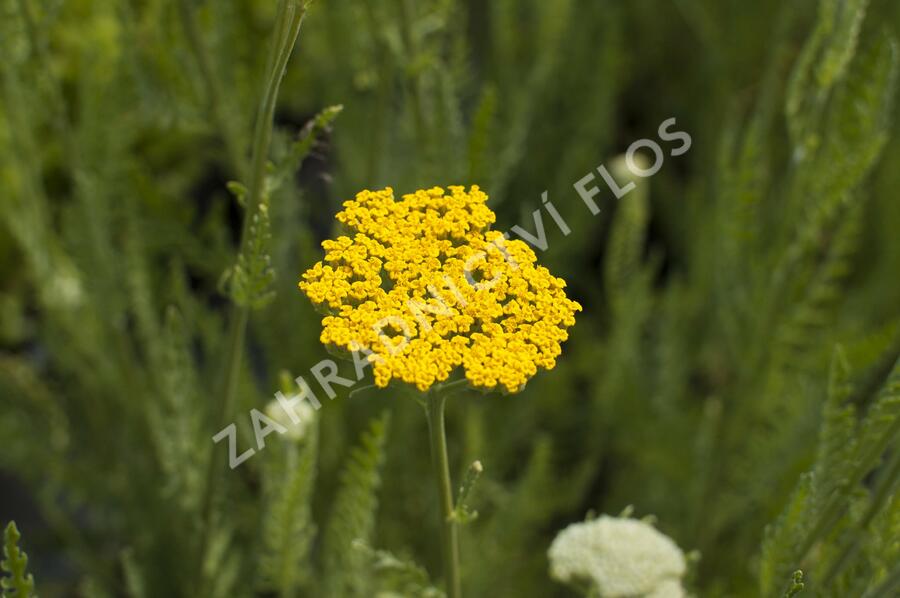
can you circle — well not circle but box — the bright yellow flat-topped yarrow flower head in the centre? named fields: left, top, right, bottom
left=299, top=186, right=581, bottom=392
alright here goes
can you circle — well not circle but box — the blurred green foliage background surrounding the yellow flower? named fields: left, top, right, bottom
left=0, top=0, right=900, bottom=598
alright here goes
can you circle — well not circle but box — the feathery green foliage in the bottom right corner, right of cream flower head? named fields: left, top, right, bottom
left=761, top=349, right=900, bottom=595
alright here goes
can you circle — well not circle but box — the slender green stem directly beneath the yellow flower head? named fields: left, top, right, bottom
left=425, top=391, right=462, bottom=598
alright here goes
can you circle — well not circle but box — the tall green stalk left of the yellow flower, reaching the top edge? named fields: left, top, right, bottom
left=199, top=0, right=310, bottom=565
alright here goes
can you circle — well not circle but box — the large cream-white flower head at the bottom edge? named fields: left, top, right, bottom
left=548, top=515, right=686, bottom=598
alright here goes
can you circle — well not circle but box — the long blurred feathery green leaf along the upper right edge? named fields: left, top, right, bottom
left=770, top=30, right=898, bottom=374
